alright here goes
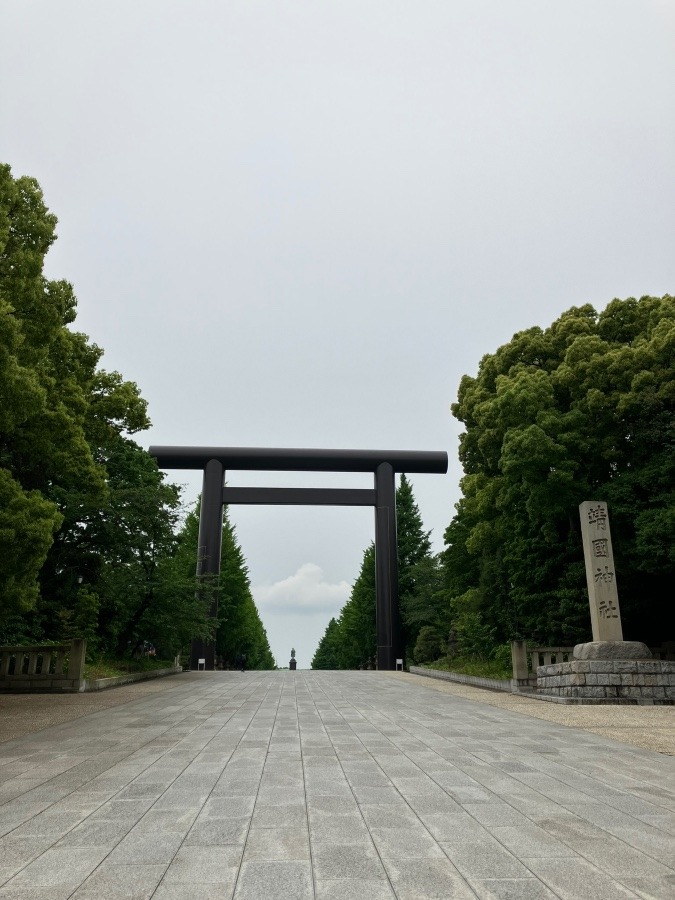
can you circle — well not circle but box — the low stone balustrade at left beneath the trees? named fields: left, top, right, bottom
left=0, top=640, right=87, bottom=691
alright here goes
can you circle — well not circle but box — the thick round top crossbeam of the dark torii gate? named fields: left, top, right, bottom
left=150, top=447, right=448, bottom=475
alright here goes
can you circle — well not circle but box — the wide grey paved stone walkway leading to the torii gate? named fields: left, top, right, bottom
left=0, top=672, right=675, bottom=900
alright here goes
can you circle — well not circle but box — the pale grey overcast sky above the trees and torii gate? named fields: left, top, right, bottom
left=0, top=0, right=675, bottom=667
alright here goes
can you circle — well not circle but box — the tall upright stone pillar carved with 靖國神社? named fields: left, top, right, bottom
left=579, top=500, right=623, bottom=641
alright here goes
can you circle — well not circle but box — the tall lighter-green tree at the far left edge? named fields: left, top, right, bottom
left=0, top=165, right=81, bottom=618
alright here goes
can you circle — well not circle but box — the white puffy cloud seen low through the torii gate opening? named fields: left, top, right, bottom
left=252, top=563, right=351, bottom=617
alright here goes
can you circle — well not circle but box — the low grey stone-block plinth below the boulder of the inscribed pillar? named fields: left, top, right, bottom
left=537, top=659, right=675, bottom=704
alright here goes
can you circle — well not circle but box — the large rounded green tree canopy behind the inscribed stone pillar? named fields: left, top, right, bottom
left=444, top=296, right=675, bottom=653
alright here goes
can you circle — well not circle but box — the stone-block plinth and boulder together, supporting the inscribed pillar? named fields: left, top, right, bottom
left=537, top=641, right=675, bottom=705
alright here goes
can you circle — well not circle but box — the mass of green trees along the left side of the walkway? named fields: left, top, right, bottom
left=0, top=165, right=273, bottom=666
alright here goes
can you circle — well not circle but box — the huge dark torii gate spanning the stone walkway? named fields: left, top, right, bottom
left=150, top=447, right=448, bottom=669
